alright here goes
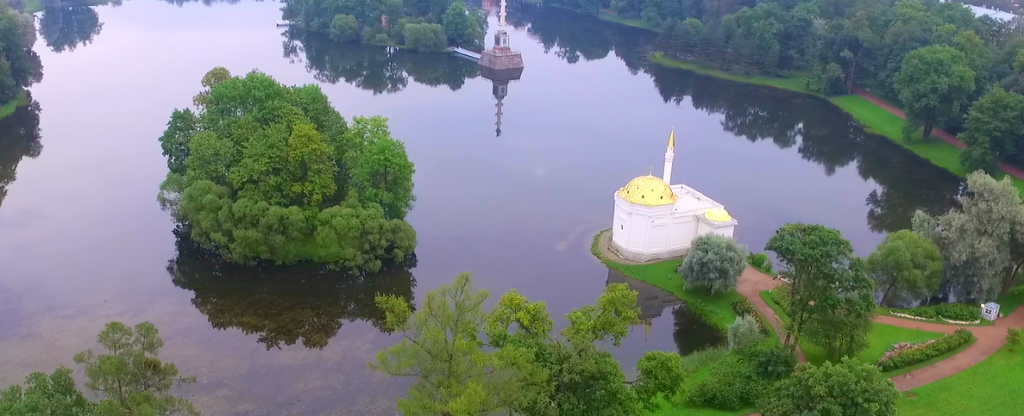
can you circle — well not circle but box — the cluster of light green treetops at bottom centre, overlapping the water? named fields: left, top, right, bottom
left=371, top=275, right=683, bottom=416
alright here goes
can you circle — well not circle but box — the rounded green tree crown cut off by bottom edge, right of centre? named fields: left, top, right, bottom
left=758, top=359, right=900, bottom=416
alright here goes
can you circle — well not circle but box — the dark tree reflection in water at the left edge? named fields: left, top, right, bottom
left=0, top=93, right=43, bottom=207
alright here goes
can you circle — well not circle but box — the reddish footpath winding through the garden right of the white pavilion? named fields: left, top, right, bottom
left=736, top=266, right=1024, bottom=390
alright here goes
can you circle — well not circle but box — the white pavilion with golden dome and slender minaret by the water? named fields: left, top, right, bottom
left=611, top=128, right=736, bottom=262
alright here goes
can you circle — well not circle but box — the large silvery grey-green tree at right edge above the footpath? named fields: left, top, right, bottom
left=913, top=171, right=1024, bottom=302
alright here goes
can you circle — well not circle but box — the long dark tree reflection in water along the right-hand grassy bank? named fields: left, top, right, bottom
left=644, top=65, right=963, bottom=232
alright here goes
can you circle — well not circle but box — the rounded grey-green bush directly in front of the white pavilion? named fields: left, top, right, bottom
left=679, top=234, right=746, bottom=293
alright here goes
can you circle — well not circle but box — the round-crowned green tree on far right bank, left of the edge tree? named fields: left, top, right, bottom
left=895, top=45, right=975, bottom=139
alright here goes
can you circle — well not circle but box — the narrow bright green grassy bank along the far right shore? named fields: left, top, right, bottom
left=650, top=52, right=1024, bottom=194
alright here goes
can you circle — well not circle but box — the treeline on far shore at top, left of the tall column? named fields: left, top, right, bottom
left=282, top=0, right=487, bottom=51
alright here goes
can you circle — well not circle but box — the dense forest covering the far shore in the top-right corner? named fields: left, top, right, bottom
left=546, top=0, right=1024, bottom=172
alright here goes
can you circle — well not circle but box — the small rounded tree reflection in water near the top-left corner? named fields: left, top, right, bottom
left=39, top=6, right=103, bottom=53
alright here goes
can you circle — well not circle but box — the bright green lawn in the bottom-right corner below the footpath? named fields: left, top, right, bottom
left=899, top=347, right=1024, bottom=416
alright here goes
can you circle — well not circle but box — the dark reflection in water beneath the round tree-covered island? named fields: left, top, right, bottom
left=167, top=232, right=416, bottom=349
